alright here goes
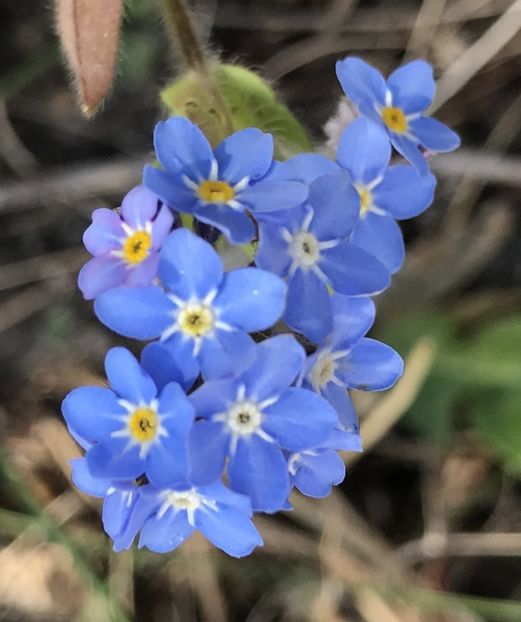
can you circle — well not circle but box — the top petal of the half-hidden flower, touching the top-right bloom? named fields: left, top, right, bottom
left=336, top=117, right=391, bottom=185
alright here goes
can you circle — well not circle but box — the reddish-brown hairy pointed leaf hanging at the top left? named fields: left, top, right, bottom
left=56, top=0, right=122, bottom=116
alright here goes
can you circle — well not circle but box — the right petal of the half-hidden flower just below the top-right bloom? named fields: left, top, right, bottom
left=373, top=164, right=436, bottom=220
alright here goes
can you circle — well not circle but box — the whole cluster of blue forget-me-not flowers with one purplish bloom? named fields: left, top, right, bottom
left=63, top=58, right=458, bottom=557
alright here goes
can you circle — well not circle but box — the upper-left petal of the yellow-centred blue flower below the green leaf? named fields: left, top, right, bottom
left=154, top=117, right=213, bottom=179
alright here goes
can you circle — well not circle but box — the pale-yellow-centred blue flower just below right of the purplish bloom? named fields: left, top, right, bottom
left=95, top=229, right=286, bottom=378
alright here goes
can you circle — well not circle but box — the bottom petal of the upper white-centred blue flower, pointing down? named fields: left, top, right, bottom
left=284, top=270, right=333, bottom=343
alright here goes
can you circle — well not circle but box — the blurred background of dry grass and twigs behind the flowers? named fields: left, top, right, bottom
left=0, top=0, right=521, bottom=622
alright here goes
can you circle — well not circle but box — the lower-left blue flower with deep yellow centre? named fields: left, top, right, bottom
left=62, top=348, right=194, bottom=486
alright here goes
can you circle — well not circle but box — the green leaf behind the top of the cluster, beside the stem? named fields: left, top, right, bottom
left=161, top=64, right=312, bottom=159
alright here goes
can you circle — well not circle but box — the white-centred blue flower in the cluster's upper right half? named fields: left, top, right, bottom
left=255, top=172, right=390, bottom=342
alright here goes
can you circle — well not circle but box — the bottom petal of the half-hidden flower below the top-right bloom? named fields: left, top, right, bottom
left=351, top=212, right=405, bottom=274
